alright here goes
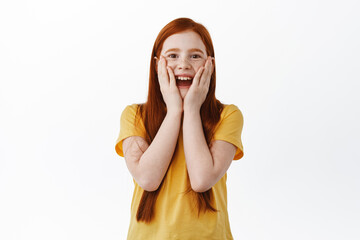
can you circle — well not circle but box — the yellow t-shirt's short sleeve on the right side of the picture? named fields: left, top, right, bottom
left=213, top=104, right=244, bottom=160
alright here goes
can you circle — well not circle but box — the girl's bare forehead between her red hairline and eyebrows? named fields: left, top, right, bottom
left=161, top=31, right=206, bottom=53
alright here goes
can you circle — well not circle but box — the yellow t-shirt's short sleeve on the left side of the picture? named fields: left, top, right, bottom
left=115, top=104, right=146, bottom=157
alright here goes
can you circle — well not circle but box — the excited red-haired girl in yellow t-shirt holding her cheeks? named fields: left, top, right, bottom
left=115, top=18, right=243, bottom=240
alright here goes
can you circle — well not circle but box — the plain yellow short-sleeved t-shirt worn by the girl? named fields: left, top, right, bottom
left=115, top=104, right=243, bottom=240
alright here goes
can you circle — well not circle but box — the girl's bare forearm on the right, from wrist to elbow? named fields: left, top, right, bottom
left=183, top=111, right=214, bottom=191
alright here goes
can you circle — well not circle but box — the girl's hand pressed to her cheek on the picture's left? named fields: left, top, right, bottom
left=158, top=56, right=183, bottom=112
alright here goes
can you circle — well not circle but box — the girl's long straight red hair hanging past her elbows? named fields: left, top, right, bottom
left=136, top=18, right=224, bottom=223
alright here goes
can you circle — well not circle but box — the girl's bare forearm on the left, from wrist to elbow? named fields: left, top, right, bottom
left=138, top=109, right=181, bottom=190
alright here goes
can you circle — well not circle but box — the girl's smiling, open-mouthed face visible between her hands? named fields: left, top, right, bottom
left=160, top=31, right=207, bottom=99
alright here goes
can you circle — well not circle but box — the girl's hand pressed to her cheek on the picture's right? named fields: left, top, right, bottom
left=184, top=56, right=214, bottom=111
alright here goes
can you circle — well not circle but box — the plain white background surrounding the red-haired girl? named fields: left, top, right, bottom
left=0, top=0, right=360, bottom=240
